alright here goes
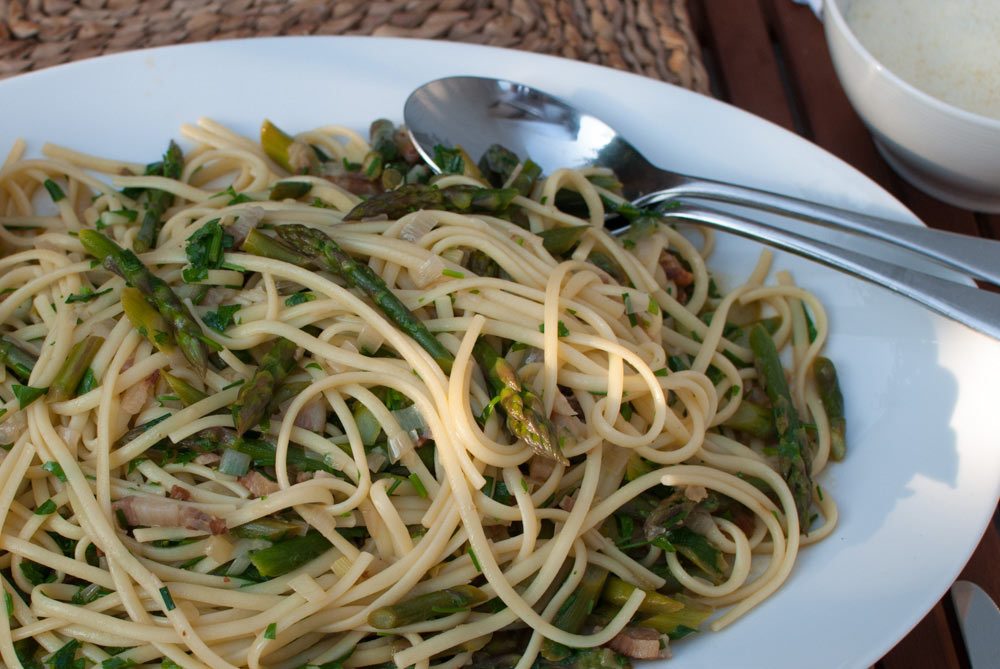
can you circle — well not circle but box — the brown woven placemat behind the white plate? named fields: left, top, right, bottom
left=0, top=0, right=708, bottom=92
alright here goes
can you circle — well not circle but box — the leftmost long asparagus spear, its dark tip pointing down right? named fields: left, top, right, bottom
left=79, top=230, right=208, bottom=372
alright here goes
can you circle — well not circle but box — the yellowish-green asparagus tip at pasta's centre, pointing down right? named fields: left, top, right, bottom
left=472, top=338, right=569, bottom=465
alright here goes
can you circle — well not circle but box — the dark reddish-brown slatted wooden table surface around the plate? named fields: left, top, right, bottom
left=688, top=0, right=1000, bottom=669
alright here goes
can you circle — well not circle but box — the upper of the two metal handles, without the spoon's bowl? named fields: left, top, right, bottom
left=635, top=177, right=1000, bottom=285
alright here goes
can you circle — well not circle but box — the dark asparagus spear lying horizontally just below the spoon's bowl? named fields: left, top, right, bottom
left=344, top=184, right=517, bottom=221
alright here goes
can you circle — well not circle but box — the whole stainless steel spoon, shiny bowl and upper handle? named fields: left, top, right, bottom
left=404, top=77, right=1000, bottom=285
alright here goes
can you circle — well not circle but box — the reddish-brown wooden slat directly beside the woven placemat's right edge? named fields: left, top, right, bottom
left=700, top=0, right=796, bottom=131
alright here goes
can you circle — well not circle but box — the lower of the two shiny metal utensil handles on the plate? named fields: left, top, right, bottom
left=666, top=205, right=1000, bottom=339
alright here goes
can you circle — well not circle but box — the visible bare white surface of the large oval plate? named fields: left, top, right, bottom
left=0, top=37, right=1000, bottom=669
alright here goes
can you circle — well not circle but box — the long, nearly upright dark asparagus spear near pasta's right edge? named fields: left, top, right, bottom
left=749, top=323, right=812, bottom=531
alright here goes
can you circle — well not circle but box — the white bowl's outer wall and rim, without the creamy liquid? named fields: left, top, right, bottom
left=823, top=0, right=1000, bottom=213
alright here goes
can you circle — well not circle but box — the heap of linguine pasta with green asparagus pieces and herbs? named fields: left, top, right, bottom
left=0, top=121, right=838, bottom=668
